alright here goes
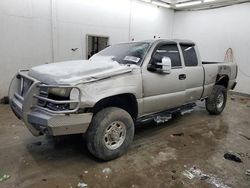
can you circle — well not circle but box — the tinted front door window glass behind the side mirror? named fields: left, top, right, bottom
left=154, top=44, right=181, bottom=67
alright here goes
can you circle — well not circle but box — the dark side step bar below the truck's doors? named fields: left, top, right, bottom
left=136, top=103, right=196, bottom=124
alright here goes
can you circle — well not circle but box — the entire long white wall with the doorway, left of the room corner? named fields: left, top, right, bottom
left=0, top=0, right=174, bottom=99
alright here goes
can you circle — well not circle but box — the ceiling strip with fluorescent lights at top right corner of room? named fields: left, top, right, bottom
left=150, top=0, right=250, bottom=11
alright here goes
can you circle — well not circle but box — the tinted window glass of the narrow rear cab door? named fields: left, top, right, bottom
left=181, top=44, right=198, bottom=67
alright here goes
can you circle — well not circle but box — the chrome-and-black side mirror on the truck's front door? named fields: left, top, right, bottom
left=148, top=57, right=172, bottom=74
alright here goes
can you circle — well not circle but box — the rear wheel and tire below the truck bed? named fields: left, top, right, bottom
left=206, top=85, right=227, bottom=115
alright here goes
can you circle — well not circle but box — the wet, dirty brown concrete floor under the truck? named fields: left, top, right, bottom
left=0, top=96, right=250, bottom=188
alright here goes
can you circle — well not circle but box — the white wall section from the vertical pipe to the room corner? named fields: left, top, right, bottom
left=54, top=0, right=174, bottom=61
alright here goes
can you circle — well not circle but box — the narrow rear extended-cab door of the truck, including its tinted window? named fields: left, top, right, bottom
left=180, top=43, right=204, bottom=103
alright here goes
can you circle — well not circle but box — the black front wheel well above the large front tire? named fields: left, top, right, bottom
left=92, top=93, right=138, bottom=120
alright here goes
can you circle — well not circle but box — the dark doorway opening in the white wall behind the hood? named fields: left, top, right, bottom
left=86, top=35, right=109, bottom=59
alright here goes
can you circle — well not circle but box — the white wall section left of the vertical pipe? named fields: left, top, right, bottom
left=0, top=0, right=51, bottom=99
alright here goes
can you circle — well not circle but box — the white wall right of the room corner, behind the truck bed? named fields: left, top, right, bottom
left=173, top=3, right=250, bottom=94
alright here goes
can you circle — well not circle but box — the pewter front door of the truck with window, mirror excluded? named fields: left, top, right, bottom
left=142, top=43, right=186, bottom=115
